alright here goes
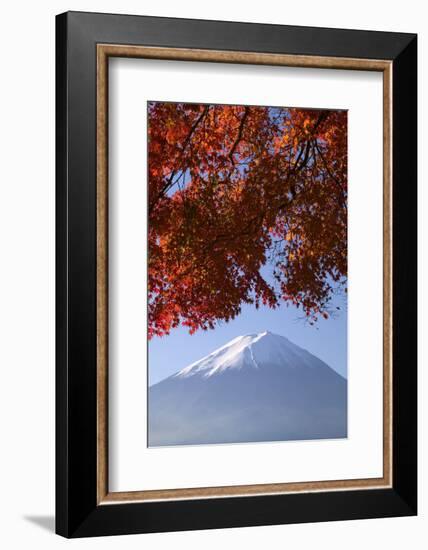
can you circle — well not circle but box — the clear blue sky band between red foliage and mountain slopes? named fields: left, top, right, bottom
left=149, top=297, right=347, bottom=385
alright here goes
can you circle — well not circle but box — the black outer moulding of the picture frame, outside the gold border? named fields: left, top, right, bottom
left=56, top=12, right=417, bottom=537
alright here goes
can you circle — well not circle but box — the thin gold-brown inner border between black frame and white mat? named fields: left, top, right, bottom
left=96, top=44, right=392, bottom=505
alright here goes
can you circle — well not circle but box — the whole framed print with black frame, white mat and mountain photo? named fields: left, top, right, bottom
left=56, top=12, right=417, bottom=537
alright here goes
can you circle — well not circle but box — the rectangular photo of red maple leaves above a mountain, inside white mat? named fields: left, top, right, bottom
left=147, top=100, right=348, bottom=447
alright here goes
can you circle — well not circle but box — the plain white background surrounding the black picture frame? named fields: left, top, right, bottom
left=0, top=0, right=422, bottom=550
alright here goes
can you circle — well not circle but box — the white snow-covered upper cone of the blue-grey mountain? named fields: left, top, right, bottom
left=174, top=331, right=306, bottom=378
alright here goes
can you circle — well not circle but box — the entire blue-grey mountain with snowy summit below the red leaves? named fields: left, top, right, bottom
left=148, top=332, right=347, bottom=447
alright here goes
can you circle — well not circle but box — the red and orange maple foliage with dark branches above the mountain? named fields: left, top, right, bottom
left=148, top=102, right=347, bottom=338
